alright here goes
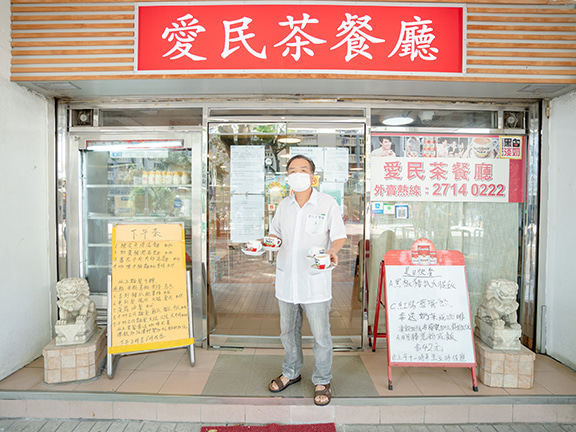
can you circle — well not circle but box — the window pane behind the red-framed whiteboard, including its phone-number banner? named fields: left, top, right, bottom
left=369, top=132, right=527, bottom=330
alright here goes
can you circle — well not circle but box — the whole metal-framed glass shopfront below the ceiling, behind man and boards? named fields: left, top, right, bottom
left=58, top=100, right=539, bottom=356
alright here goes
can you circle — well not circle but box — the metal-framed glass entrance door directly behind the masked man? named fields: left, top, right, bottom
left=207, top=122, right=366, bottom=348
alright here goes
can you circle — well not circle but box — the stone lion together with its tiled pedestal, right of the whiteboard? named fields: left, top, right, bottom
left=474, top=279, right=536, bottom=389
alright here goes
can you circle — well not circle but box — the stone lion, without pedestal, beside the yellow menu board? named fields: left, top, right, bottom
left=55, top=278, right=96, bottom=345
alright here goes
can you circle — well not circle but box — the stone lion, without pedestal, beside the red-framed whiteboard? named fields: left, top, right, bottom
left=474, top=279, right=522, bottom=350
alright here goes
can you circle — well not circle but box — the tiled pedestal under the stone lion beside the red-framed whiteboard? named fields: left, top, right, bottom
left=475, top=340, right=536, bottom=389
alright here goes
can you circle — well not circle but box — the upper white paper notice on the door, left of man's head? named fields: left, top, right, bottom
left=230, top=145, right=264, bottom=194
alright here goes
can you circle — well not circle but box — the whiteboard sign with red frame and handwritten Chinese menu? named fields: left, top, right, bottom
left=382, top=239, right=478, bottom=391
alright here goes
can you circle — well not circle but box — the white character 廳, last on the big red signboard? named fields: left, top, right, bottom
left=388, top=16, right=438, bottom=61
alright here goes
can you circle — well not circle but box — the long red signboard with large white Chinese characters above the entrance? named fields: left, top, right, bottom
left=136, top=3, right=464, bottom=74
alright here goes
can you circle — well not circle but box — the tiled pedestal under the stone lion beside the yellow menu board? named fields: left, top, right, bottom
left=42, top=327, right=106, bottom=384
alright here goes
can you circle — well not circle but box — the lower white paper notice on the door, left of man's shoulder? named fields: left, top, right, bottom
left=230, top=195, right=264, bottom=243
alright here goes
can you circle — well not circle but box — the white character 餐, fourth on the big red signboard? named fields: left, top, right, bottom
left=330, top=13, right=385, bottom=62
